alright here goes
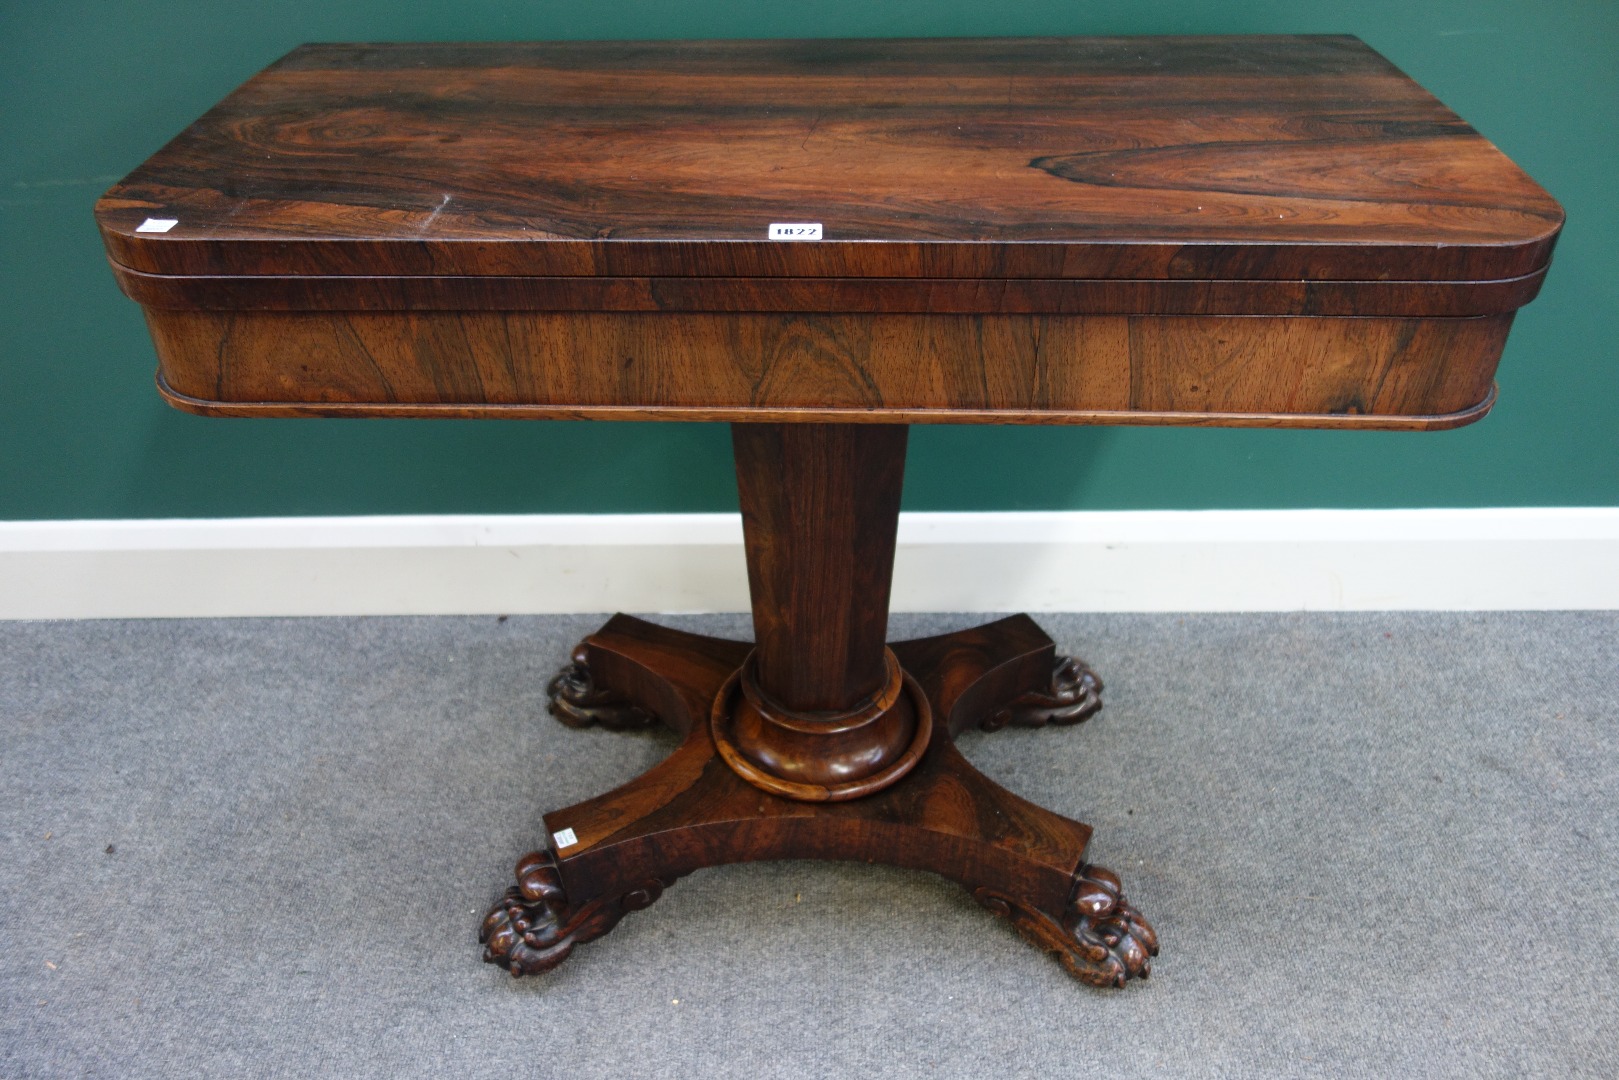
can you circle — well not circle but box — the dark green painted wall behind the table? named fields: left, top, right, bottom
left=0, top=0, right=1619, bottom=520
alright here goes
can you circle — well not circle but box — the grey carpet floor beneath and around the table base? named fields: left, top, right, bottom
left=0, top=614, right=1619, bottom=1080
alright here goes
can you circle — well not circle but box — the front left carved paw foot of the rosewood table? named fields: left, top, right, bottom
left=478, top=852, right=667, bottom=978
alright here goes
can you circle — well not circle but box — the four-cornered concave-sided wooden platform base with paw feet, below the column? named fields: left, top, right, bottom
left=479, top=615, right=1158, bottom=988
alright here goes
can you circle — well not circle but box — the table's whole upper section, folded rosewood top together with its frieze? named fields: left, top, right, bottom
left=97, top=37, right=1562, bottom=427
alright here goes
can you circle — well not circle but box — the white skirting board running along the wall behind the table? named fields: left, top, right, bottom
left=0, top=507, right=1619, bottom=619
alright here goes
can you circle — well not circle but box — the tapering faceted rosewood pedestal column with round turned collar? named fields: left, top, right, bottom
left=711, top=424, right=933, bottom=801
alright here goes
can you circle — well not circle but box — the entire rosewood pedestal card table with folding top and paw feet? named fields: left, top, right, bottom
left=97, top=37, right=1562, bottom=986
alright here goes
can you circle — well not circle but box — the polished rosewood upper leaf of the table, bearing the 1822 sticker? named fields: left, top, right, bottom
left=97, top=37, right=1562, bottom=282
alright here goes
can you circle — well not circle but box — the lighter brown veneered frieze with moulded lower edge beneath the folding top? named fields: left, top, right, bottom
left=147, top=311, right=1512, bottom=427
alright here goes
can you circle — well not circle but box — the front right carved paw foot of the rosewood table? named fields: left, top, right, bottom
left=973, top=865, right=1158, bottom=988
